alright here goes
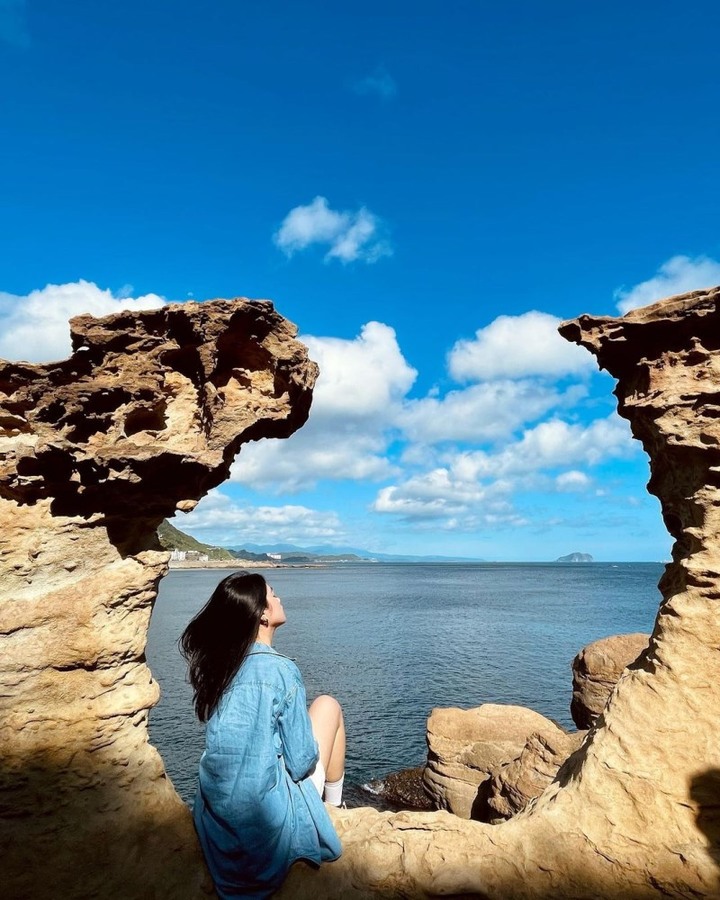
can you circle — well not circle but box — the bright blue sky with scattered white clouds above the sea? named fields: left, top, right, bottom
left=0, top=0, right=720, bottom=560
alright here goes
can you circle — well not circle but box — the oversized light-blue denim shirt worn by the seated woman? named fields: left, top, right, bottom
left=193, top=642, right=342, bottom=900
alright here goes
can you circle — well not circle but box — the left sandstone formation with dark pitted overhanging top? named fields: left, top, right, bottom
left=0, top=300, right=317, bottom=900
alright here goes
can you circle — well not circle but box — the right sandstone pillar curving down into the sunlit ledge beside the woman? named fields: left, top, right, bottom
left=279, top=288, right=720, bottom=900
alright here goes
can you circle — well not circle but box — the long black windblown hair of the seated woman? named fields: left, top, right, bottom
left=178, top=574, right=267, bottom=722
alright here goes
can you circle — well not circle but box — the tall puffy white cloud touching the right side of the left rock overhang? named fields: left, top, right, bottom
left=232, top=322, right=417, bottom=491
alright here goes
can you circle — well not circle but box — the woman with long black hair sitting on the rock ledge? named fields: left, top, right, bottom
left=180, top=574, right=345, bottom=900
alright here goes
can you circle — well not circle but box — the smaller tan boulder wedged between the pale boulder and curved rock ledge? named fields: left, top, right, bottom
left=483, top=728, right=587, bottom=823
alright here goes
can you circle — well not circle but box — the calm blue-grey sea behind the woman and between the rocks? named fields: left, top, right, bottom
left=147, top=563, right=663, bottom=801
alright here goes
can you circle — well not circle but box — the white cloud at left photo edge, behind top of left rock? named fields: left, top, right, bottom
left=0, top=279, right=166, bottom=362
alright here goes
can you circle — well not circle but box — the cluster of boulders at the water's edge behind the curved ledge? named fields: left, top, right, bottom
left=366, top=634, right=650, bottom=824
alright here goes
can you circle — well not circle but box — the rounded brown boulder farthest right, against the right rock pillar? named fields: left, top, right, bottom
left=570, top=634, right=650, bottom=728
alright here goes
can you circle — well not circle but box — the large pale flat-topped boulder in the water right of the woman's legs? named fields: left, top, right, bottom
left=423, top=703, right=564, bottom=819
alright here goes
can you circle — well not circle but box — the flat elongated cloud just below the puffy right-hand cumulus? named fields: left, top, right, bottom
left=398, top=380, right=586, bottom=443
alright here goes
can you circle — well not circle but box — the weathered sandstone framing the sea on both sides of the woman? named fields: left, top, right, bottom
left=7, top=288, right=720, bottom=900
